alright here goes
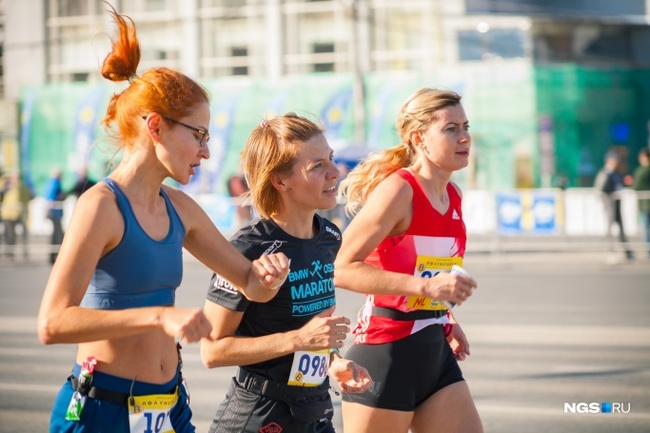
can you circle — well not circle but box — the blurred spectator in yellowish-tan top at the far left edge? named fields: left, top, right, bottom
left=0, top=172, right=34, bottom=257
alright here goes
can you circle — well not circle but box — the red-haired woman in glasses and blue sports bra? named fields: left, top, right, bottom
left=38, top=7, right=288, bottom=433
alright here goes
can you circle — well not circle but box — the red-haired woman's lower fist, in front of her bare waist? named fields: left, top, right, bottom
left=160, top=307, right=212, bottom=343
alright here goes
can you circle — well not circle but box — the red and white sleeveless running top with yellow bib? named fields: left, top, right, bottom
left=353, top=169, right=467, bottom=344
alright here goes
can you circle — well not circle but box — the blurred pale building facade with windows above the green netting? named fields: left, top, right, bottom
left=0, top=0, right=650, bottom=86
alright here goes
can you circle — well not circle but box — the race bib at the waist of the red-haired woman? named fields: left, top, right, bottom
left=129, top=388, right=178, bottom=433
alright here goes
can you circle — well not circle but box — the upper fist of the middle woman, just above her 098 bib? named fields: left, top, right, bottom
left=295, top=307, right=350, bottom=350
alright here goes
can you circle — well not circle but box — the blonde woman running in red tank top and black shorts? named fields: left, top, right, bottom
left=335, top=88, right=483, bottom=433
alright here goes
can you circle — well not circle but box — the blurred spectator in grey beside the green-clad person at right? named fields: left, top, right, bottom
left=594, top=152, right=634, bottom=260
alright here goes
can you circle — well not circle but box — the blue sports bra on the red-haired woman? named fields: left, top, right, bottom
left=81, top=178, right=185, bottom=310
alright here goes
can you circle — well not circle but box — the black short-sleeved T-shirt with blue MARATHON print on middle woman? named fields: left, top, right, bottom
left=207, top=215, right=341, bottom=384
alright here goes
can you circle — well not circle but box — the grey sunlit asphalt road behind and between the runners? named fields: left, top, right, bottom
left=0, top=248, right=650, bottom=433
